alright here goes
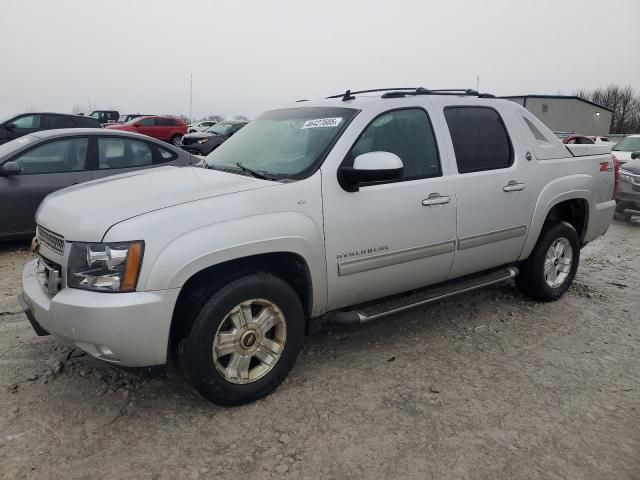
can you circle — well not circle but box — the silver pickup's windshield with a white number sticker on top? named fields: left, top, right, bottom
left=205, top=107, right=358, bottom=179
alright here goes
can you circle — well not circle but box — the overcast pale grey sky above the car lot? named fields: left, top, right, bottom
left=0, top=0, right=640, bottom=118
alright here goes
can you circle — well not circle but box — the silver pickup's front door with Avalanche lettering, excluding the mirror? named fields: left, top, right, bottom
left=322, top=107, right=456, bottom=310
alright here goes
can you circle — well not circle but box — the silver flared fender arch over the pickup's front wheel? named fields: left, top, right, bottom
left=145, top=212, right=327, bottom=316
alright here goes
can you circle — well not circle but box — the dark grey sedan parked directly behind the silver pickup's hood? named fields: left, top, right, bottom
left=0, top=129, right=195, bottom=239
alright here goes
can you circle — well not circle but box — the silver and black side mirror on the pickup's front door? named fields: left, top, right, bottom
left=338, top=152, right=404, bottom=192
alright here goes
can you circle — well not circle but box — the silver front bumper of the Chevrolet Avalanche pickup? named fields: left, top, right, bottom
left=19, top=261, right=180, bottom=367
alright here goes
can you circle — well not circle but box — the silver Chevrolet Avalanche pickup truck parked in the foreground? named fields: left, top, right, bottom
left=20, top=88, right=616, bottom=405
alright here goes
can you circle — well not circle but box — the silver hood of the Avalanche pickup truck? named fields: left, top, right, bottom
left=36, top=167, right=278, bottom=242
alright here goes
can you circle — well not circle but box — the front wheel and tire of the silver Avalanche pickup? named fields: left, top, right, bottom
left=177, top=273, right=305, bottom=406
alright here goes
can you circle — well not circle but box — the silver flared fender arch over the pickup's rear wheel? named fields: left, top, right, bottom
left=520, top=174, right=594, bottom=260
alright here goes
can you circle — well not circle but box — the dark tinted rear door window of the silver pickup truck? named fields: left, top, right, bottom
left=444, top=107, right=513, bottom=173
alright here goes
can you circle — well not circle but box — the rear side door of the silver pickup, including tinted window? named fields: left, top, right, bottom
left=444, top=105, right=531, bottom=278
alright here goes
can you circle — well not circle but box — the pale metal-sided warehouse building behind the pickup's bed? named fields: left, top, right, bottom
left=502, top=95, right=613, bottom=135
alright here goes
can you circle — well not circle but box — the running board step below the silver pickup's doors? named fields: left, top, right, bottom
left=325, top=267, right=518, bottom=325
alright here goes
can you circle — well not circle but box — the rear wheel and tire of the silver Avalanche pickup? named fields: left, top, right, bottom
left=516, top=222, right=580, bottom=302
